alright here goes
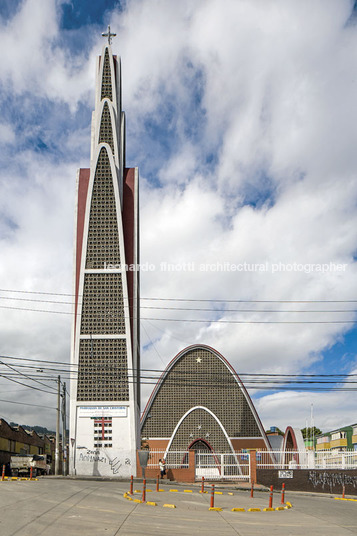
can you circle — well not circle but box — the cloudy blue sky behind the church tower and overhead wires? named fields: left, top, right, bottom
left=0, top=0, right=357, bottom=429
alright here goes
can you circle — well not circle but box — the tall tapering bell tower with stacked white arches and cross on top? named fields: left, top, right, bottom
left=69, top=27, right=140, bottom=477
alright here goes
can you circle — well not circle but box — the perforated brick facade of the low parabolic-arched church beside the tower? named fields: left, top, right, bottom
left=141, top=346, right=265, bottom=452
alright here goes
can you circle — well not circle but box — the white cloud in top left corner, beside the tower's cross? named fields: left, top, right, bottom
left=0, top=0, right=94, bottom=111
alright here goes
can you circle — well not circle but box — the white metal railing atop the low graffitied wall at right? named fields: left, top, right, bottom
left=256, top=450, right=357, bottom=469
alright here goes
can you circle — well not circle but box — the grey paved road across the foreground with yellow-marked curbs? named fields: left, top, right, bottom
left=0, top=478, right=357, bottom=536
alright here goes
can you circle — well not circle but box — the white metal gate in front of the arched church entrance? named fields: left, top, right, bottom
left=195, top=451, right=250, bottom=481
